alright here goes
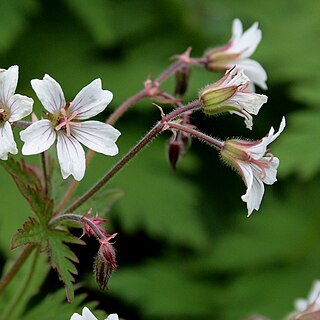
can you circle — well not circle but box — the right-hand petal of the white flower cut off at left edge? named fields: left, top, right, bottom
left=7, top=94, right=33, bottom=122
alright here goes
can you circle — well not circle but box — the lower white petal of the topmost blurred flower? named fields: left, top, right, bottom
left=235, top=59, right=268, bottom=90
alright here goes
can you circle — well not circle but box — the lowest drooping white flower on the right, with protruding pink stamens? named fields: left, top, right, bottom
left=220, top=117, right=286, bottom=216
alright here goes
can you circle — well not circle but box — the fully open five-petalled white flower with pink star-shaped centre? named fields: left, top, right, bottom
left=20, top=75, right=120, bottom=181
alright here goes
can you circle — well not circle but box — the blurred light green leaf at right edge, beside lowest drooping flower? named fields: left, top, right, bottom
left=272, top=110, right=320, bottom=180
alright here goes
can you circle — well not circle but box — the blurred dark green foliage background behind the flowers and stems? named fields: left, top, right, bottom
left=0, top=0, right=320, bottom=320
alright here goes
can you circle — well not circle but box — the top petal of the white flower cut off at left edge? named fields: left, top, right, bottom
left=0, top=66, right=19, bottom=105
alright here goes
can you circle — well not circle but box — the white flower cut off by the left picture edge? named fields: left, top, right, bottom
left=0, top=66, right=33, bottom=160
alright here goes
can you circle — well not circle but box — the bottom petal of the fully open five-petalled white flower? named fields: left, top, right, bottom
left=57, top=133, right=86, bottom=181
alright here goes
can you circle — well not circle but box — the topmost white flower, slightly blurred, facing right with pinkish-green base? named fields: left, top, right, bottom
left=205, top=19, right=267, bottom=89
